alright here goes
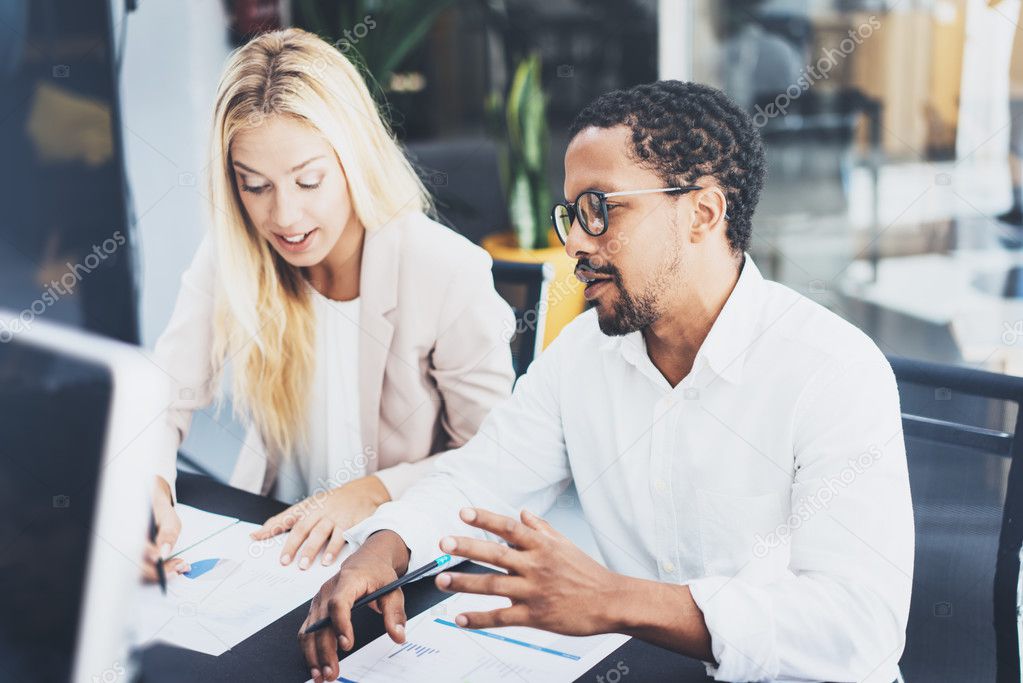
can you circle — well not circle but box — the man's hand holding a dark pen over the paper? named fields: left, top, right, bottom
left=299, top=531, right=409, bottom=683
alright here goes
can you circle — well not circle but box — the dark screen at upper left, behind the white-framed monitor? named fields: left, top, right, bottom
left=0, top=0, right=138, bottom=344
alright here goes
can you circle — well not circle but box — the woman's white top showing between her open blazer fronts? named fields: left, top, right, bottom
left=276, top=285, right=367, bottom=504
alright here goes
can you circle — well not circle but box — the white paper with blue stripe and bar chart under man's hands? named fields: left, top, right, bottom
left=319, top=593, right=629, bottom=683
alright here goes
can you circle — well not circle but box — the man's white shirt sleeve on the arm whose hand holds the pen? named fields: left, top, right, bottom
left=345, top=323, right=570, bottom=568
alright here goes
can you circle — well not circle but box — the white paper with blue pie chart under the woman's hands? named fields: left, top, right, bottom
left=136, top=505, right=349, bottom=655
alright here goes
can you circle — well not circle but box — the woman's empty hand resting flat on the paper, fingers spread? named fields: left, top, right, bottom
left=252, top=475, right=391, bottom=570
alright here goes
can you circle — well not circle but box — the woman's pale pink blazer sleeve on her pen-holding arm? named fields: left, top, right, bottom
left=152, top=236, right=216, bottom=499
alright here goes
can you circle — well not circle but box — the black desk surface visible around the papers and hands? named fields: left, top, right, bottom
left=142, top=473, right=711, bottom=683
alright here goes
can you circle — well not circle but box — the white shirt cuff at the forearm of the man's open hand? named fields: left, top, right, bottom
left=688, top=577, right=780, bottom=681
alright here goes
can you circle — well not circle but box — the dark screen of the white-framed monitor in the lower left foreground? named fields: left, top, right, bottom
left=0, top=337, right=114, bottom=682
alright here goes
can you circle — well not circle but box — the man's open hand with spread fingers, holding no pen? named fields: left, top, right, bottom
left=436, top=508, right=622, bottom=636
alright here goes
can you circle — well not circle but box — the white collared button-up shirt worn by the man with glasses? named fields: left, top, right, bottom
left=346, top=256, right=914, bottom=683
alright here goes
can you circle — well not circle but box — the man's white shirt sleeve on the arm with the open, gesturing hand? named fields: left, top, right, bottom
left=690, top=353, right=914, bottom=683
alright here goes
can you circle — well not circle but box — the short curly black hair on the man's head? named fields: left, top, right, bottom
left=570, top=81, right=765, bottom=254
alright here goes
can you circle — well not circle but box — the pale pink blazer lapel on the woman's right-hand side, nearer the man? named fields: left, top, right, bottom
left=359, top=224, right=401, bottom=466
